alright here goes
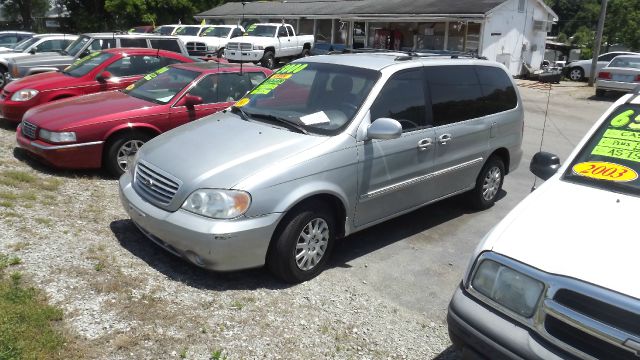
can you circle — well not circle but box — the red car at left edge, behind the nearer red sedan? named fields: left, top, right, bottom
left=0, top=48, right=193, bottom=123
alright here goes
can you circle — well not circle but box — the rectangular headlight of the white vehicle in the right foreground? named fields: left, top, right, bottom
left=471, top=260, right=544, bottom=318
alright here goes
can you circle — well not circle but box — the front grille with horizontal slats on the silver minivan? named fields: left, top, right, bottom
left=134, top=162, right=180, bottom=205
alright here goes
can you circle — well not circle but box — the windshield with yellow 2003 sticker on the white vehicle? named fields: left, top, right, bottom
left=563, top=104, right=640, bottom=195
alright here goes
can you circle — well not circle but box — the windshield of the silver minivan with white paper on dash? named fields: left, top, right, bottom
left=234, top=63, right=380, bottom=135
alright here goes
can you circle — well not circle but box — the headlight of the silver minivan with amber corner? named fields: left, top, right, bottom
left=182, top=189, right=251, bottom=219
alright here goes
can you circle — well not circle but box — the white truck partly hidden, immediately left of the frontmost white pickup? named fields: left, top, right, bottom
left=179, top=25, right=244, bottom=57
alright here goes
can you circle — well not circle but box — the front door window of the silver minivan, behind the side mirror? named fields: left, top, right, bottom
left=371, top=68, right=431, bottom=132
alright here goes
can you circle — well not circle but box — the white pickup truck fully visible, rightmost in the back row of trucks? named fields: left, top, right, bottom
left=224, top=23, right=314, bottom=69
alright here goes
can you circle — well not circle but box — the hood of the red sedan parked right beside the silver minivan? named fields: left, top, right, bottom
left=23, top=91, right=158, bottom=131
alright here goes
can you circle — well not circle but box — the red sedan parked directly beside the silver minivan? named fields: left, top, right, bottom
left=16, top=62, right=271, bottom=176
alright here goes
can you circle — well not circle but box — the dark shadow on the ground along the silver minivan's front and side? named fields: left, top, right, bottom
left=110, top=190, right=506, bottom=291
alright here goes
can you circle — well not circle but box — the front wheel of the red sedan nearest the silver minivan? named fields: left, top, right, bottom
left=102, top=132, right=151, bottom=177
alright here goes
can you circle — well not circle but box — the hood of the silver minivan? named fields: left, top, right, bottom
left=139, top=112, right=328, bottom=191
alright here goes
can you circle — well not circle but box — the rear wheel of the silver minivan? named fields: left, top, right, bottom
left=469, top=156, right=504, bottom=210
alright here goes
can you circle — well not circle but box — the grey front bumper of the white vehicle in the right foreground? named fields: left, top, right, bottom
left=447, top=286, right=563, bottom=360
